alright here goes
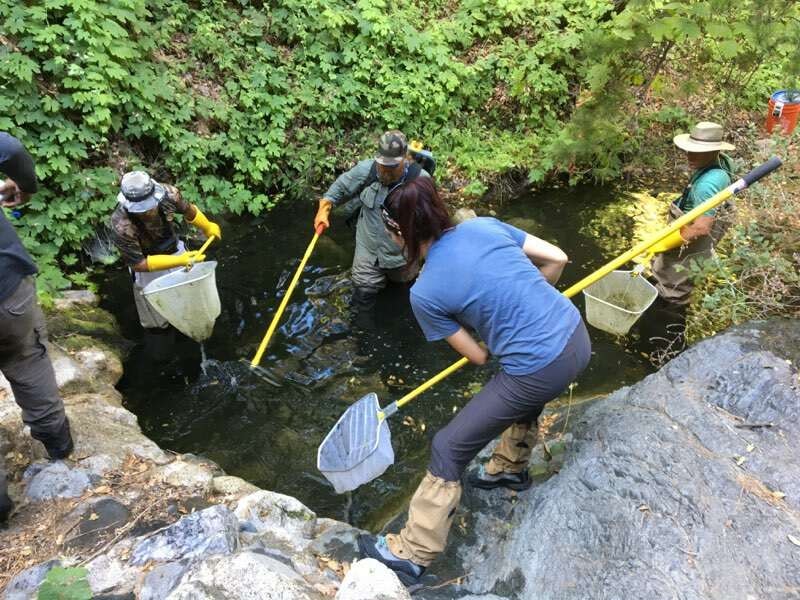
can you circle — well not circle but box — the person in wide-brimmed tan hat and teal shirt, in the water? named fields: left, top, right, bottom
left=651, top=121, right=734, bottom=306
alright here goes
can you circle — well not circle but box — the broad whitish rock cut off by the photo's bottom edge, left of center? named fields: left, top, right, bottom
left=167, top=552, right=320, bottom=600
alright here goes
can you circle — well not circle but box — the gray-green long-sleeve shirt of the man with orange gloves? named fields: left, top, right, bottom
left=325, top=159, right=430, bottom=269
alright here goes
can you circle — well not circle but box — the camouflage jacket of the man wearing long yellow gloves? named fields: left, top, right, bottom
left=111, top=183, right=189, bottom=267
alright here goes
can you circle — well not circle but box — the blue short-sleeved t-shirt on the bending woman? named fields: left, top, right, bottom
left=411, top=217, right=581, bottom=375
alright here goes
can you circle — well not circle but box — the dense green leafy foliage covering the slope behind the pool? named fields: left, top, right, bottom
left=0, top=0, right=800, bottom=294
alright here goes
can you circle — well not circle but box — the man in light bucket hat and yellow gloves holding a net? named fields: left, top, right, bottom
left=111, top=171, right=222, bottom=354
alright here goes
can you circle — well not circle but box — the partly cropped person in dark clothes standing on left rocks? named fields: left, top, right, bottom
left=0, top=132, right=73, bottom=522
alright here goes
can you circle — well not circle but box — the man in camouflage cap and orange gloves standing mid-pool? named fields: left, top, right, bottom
left=314, top=130, right=430, bottom=329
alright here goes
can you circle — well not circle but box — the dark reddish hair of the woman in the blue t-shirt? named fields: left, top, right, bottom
left=384, top=177, right=453, bottom=264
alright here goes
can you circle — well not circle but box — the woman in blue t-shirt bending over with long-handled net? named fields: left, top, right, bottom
left=358, top=178, right=591, bottom=585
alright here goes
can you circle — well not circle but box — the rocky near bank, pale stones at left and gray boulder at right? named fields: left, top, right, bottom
left=0, top=297, right=800, bottom=600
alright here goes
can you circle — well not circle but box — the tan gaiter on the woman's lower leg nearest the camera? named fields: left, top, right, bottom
left=386, top=472, right=461, bottom=567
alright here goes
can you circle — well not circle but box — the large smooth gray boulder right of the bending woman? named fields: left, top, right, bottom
left=446, top=321, right=800, bottom=600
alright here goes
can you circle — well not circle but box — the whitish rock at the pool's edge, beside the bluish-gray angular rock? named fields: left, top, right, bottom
left=234, top=490, right=317, bottom=548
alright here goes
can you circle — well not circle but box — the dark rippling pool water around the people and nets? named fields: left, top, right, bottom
left=95, top=187, right=652, bottom=527
